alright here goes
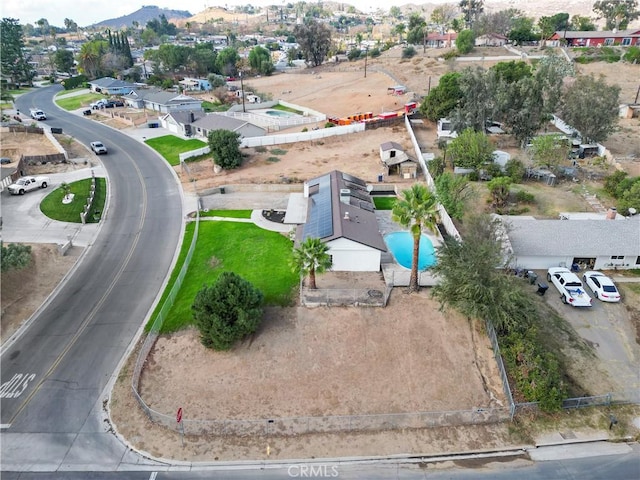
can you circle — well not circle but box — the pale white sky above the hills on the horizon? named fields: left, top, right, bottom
left=0, top=0, right=444, bottom=27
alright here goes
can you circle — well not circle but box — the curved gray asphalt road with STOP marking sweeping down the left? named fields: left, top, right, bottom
left=0, top=85, right=183, bottom=471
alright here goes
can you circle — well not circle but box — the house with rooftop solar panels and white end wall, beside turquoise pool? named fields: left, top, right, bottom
left=296, top=170, right=387, bottom=272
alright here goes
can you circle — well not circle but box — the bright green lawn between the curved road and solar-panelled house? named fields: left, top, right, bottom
left=152, top=222, right=298, bottom=333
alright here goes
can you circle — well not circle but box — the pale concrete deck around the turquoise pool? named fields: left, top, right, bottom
left=376, top=210, right=442, bottom=287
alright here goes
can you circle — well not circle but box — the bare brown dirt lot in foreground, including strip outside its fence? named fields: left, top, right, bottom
left=111, top=290, right=504, bottom=460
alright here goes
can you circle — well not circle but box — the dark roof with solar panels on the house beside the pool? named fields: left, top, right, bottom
left=302, top=170, right=387, bottom=252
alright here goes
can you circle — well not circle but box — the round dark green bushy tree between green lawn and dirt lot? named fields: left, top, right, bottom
left=191, top=272, right=263, bottom=350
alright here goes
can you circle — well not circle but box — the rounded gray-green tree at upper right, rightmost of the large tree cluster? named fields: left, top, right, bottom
left=560, top=75, right=620, bottom=143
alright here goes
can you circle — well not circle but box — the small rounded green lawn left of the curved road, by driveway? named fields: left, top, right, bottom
left=40, top=177, right=107, bottom=223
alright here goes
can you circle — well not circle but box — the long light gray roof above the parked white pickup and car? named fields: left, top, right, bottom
left=501, top=216, right=640, bottom=257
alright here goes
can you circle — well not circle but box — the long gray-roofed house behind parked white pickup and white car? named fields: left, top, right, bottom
left=500, top=213, right=640, bottom=270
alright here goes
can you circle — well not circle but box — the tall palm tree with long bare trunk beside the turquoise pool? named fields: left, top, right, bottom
left=391, top=183, right=438, bottom=292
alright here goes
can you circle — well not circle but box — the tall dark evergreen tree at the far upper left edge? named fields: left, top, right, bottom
left=0, top=18, right=35, bottom=86
